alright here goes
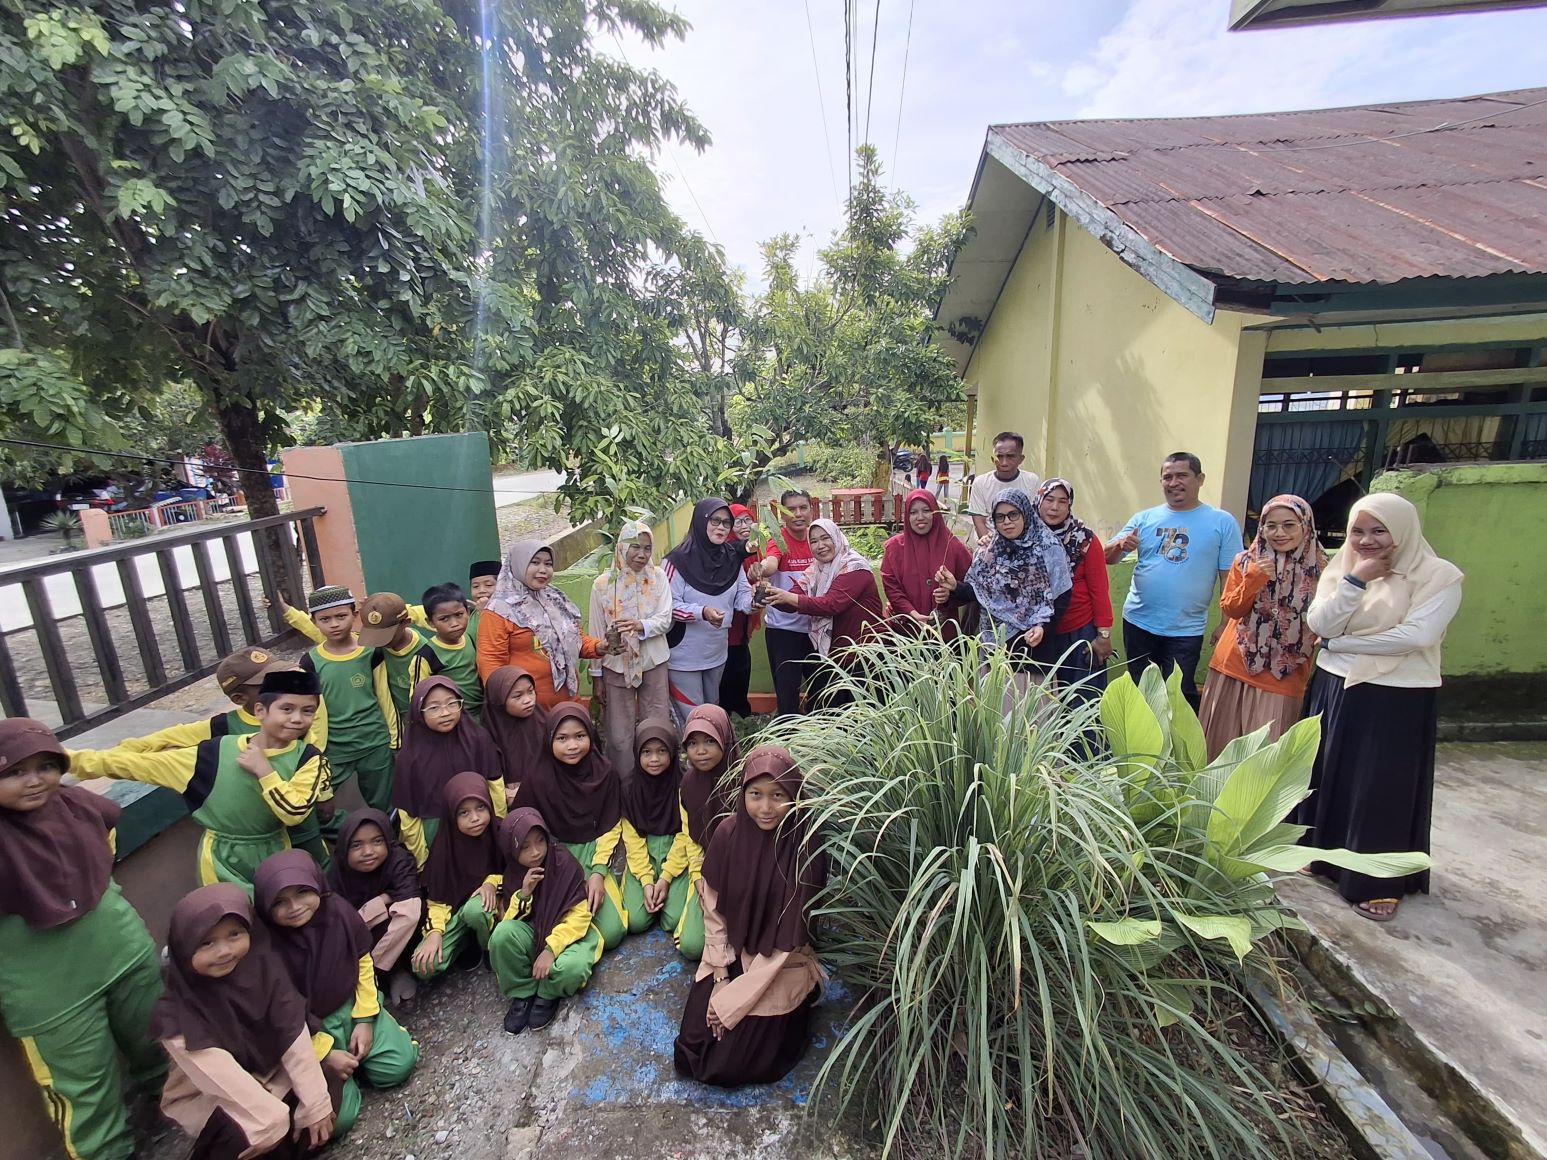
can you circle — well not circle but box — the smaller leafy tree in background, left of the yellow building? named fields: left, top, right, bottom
left=730, top=145, right=968, bottom=476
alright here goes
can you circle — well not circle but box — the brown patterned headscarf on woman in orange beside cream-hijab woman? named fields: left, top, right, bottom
left=1236, top=495, right=1327, bottom=681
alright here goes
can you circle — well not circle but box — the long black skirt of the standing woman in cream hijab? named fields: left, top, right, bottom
left=1295, top=668, right=1439, bottom=903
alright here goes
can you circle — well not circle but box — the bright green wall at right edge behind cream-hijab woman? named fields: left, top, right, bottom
left=1371, top=462, right=1547, bottom=676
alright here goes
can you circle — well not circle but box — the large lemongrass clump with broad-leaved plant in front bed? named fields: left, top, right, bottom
left=770, top=639, right=1426, bottom=1160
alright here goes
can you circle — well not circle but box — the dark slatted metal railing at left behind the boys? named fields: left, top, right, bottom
left=0, top=507, right=326, bottom=738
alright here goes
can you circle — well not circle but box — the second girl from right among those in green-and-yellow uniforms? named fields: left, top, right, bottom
left=623, top=718, right=693, bottom=934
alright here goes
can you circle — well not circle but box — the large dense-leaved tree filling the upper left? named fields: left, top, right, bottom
left=0, top=0, right=736, bottom=515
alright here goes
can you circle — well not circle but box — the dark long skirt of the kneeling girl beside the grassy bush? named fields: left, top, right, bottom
left=673, top=968, right=817, bottom=1087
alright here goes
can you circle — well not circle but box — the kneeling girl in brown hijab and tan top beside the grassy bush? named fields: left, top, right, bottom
left=674, top=745, right=828, bottom=1087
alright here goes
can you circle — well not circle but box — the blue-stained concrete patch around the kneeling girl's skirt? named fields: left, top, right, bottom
left=569, top=931, right=849, bottom=1109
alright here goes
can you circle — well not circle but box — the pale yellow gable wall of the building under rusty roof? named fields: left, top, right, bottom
left=965, top=213, right=1265, bottom=537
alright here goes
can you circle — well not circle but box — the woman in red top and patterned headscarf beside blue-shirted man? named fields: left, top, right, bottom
left=1036, top=476, right=1112, bottom=698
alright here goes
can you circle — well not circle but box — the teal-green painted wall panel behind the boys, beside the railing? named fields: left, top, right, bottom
left=339, top=432, right=500, bottom=603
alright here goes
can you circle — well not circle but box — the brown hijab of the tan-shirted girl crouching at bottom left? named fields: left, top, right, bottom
left=150, top=882, right=306, bottom=1076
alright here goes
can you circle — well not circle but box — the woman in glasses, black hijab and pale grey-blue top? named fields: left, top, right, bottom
left=665, top=498, right=752, bottom=727
